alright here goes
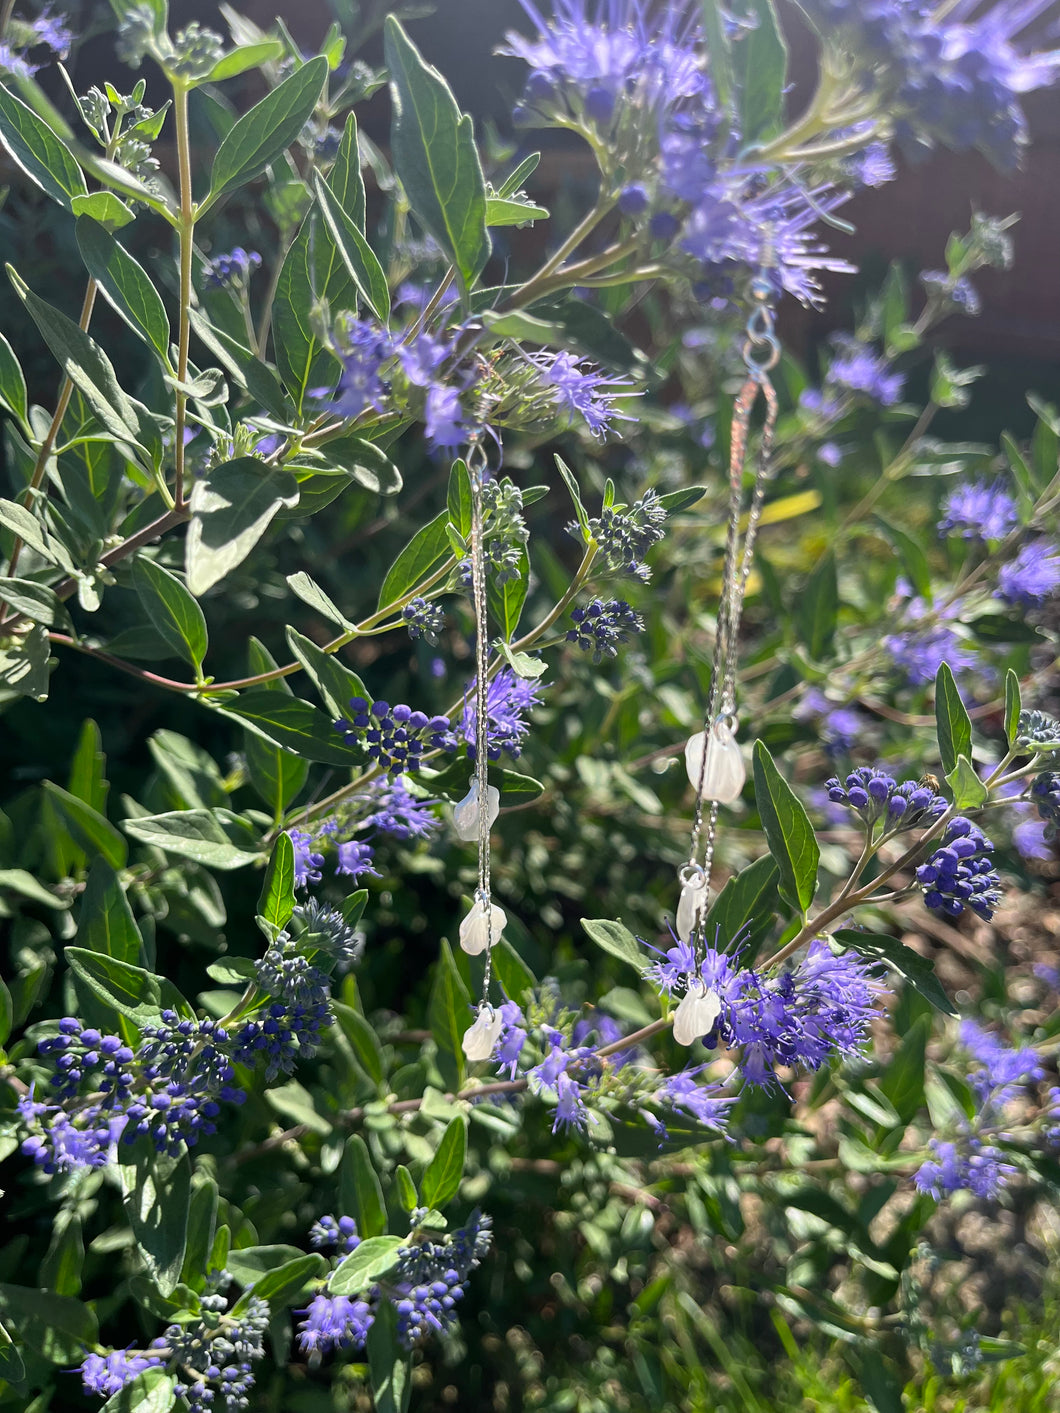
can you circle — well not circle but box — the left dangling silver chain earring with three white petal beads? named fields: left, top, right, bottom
left=454, top=441, right=507, bottom=1060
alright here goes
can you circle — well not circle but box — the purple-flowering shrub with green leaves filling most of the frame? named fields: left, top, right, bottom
left=0, top=0, right=1060, bottom=1413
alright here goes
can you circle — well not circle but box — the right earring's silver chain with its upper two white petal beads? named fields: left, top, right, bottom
left=676, top=268, right=780, bottom=951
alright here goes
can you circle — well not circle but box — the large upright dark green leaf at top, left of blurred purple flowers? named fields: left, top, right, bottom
left=383, top=14, right=490, bottom=288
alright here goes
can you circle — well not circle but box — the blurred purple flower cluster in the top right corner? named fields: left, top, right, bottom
left=804, top=0, right=1060, bottom=167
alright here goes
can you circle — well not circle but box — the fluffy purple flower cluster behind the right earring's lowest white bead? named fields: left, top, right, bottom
left=646, top=940, right=883, bottom=1088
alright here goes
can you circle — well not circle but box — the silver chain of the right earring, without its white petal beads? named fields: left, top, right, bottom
left=681, top=276, right=780, bottom=950
